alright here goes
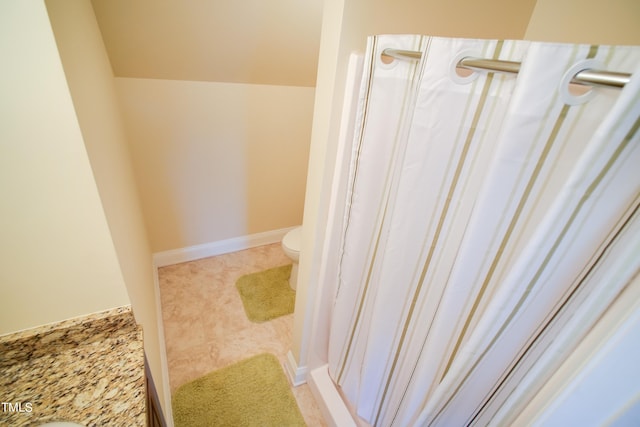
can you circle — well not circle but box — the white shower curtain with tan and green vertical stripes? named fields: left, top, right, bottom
left=323, top=36, right=640, bottom=426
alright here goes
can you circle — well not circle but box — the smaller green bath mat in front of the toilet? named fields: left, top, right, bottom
left=236, top=264, right=296, bottom=323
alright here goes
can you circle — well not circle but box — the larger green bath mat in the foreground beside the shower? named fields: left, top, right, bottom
left=172, top=353, right=306, bottom=427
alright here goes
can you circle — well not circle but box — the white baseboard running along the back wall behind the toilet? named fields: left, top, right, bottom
left=153, top=227, right=296, bottom=267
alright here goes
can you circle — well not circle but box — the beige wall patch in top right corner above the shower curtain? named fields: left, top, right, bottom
left=525, top=0, right=640, bottom=45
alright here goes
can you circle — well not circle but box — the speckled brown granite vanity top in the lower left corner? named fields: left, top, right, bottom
left=0, top=307, right=146, bottom=427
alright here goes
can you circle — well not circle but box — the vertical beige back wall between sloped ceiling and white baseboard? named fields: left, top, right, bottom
left=116, top=78, right=314, bottom=252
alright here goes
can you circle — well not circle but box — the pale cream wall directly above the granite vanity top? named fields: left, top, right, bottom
left=0, top=0, right=129, bottom=334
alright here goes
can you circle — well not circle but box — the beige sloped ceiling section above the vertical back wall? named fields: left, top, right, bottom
left=92, top=0, right=322, bottom=86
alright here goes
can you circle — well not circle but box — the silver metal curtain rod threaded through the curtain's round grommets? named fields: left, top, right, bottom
left=382, top=49, right=631, bottom=88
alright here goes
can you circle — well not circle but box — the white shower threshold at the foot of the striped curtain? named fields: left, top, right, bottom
left=309, top=365, right=357, bottom=427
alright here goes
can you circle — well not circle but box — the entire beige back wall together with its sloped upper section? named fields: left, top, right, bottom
left=91, top=0, right=322, bottom=252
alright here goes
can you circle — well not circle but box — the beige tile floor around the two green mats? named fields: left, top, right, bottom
left=158, top=243, right=326, bottom=427
